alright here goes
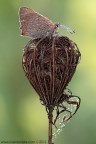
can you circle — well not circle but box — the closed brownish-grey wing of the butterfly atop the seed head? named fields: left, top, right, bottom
left=19, top=7, right=55, bottom=39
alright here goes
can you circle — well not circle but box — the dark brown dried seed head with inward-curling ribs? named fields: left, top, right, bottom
left=22, top=36, right=81, bottom=107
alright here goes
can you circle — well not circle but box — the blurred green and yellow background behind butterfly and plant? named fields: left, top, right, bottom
left=0, top=0, right=96, bottom=144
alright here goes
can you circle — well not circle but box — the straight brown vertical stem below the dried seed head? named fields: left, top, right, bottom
left=48, top=107, right=53, bottom=144
